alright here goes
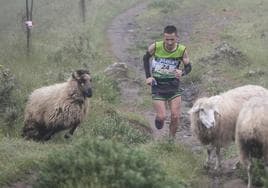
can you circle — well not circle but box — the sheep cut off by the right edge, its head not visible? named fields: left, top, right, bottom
left=235, top=96, right=268, bottom=188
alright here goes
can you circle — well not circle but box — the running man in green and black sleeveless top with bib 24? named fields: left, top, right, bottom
left=143, top=25, right=192, bottom=139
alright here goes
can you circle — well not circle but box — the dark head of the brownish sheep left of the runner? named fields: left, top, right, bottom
left=72, top=70, right=92, bottom=97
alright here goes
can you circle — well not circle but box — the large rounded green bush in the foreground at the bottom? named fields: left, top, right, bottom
left=34, top=138, right=174, bottom=188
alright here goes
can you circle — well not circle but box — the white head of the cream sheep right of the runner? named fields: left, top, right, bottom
left=189, top=96, right=220, bottom=129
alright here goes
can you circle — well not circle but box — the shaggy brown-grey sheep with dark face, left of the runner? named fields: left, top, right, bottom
left=22, top=70, right=92, bottom=140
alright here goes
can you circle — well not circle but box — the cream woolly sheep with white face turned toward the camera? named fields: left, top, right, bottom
left=189, top=85, right=268, bottom=170
